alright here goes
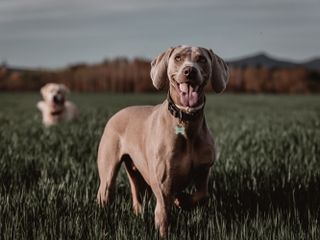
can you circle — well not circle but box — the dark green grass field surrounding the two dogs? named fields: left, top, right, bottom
left=0, top=93, right=320, bottom=240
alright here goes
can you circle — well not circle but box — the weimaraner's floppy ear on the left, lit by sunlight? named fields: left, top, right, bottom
left=150, top=48, right=174, bottom=90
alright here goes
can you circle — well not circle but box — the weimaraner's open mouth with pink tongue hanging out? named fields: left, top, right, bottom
left=177, top=82, right=200, bottom=107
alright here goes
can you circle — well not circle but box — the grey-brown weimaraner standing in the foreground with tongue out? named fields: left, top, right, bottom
left=97, top=46, right=229, bottom=237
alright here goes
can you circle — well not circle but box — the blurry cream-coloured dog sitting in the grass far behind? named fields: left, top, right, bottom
left=37, top=83, right=78, bottom=127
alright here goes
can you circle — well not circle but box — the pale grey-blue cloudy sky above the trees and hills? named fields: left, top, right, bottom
left=0, top=0, right=320, bottom=68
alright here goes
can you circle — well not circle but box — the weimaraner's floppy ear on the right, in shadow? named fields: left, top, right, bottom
left=209, top=49, right=230, bottom=93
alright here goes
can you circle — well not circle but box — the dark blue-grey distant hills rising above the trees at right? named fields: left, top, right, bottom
left=228, top=53, right=320, bottom=71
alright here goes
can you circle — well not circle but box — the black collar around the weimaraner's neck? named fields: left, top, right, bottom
left=167, top=92, right=206, bottom=121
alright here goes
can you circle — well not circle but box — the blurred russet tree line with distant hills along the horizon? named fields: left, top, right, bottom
left=0, top=53, right=320, bottom=94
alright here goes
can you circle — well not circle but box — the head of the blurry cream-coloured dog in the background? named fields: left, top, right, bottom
left=40, top=83, right=69, bottom=106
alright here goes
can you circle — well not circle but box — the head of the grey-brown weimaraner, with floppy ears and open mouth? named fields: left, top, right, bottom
left=150, top=46, right=229, bottom=107
